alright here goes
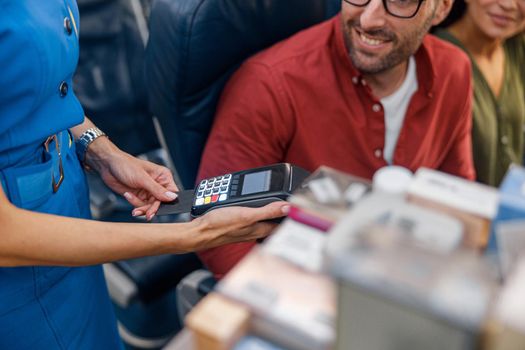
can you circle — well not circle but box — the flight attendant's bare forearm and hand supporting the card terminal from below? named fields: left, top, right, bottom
left=0, top=188, right=288, bottom=266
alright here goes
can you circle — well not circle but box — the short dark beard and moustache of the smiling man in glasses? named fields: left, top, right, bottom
left=344, top=14, right=434, bottom=74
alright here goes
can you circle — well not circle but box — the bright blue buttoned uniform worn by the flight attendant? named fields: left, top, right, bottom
left=0, top=0, right=121, bottom=350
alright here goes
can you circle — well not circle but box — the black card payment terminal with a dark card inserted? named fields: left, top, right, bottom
left=157, top=163, right=309, bottom=217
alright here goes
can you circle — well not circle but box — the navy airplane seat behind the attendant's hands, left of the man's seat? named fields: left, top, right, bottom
left=74, top=0, right=202, bottom=349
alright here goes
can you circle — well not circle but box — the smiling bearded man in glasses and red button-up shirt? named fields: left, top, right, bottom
left=199, top=0, right=474, bottom=278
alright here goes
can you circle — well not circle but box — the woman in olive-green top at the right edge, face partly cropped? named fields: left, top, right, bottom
left=435, top=0, right=525, bottom=186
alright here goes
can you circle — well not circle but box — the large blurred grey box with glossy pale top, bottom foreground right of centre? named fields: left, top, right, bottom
left=329, top=224, right=494, bottom=350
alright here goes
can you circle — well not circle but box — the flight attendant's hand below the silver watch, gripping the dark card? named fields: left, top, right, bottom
left=86, top=138, right=178, bottom=220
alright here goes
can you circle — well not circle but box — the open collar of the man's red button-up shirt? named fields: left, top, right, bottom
left=332, top=13, right=436, bottom=97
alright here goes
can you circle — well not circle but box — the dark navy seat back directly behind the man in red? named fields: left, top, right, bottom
left=146, top=0, right=341, bottom=187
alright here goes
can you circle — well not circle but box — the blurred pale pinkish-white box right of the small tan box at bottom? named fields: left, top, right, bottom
left=217, top=248, right=336, bottom=350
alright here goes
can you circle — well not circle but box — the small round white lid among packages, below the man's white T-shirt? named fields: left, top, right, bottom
left=372, top=165, right=413, bottom=194
